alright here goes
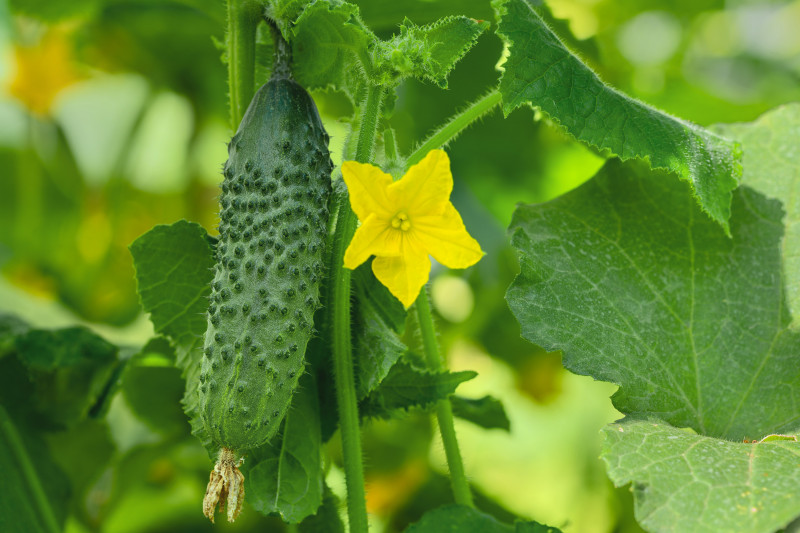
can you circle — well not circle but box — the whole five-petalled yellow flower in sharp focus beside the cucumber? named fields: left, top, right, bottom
left=342, top=150, right=483, bottom=309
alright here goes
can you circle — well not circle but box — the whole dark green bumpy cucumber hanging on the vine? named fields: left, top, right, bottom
left=199, top=79, right=333, bottom=453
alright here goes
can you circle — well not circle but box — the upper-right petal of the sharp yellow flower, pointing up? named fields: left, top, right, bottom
left=388, top=150, right=453, bottom=218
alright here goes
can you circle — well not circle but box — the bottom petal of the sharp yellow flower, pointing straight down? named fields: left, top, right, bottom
left=372, top=234, right=431, bottom=309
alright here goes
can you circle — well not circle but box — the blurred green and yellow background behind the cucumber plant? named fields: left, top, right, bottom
left=0, top=0, right=800, bottom=533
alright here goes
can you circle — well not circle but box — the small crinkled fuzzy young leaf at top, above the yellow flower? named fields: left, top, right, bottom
left=374, top=16, right=489, bottom=89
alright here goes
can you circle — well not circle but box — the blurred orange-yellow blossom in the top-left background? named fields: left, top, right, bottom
left=9, top=30, right=79, bottom=115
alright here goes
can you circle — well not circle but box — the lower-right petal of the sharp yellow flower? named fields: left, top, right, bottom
left=412, top=202, right=483, bottom=268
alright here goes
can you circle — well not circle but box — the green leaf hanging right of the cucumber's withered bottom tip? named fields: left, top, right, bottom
left=243, top=374, right=323, bottom=524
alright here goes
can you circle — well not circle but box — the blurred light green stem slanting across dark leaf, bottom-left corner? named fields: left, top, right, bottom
left=0, top=406, right=61, bottom=533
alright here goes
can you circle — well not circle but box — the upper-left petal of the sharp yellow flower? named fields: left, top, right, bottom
left=342, top=161, right=395, bottom=222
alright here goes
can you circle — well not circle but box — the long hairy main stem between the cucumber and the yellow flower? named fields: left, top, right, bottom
left=329, top=82, right=383, bottom=533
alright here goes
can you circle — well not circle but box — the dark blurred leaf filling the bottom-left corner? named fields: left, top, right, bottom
left=0, top=405, right=69, bottom=533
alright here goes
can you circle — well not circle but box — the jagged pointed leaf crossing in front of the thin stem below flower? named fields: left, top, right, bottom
left=359, top=361, right=478, bottom=417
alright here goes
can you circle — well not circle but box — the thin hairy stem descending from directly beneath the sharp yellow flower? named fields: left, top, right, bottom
left=416, top=289, right=472, bottom=507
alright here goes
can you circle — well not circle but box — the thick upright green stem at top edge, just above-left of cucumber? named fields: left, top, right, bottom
left=226, top=0, right=261, bottom=130
